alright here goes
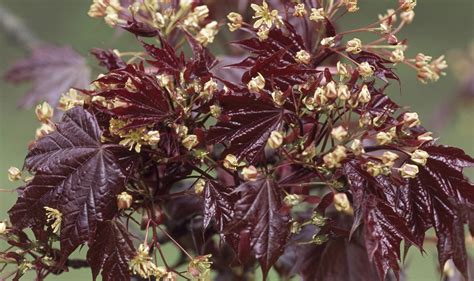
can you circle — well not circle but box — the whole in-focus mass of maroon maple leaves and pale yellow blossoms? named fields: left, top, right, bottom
left=0, top=0, right=474, bottom=280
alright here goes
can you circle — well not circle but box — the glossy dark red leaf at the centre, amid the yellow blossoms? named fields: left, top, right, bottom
left=207, top=96, right=283, bottom=163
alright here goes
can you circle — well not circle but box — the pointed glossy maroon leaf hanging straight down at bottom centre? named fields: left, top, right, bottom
left=234, top=179, right=289, bottom=276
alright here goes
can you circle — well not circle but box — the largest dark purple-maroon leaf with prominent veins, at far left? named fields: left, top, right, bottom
left=9, top=107, right=125, bottom=259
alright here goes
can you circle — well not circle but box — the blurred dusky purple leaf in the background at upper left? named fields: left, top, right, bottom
left=5, top=45, right=90, bottom=108
